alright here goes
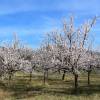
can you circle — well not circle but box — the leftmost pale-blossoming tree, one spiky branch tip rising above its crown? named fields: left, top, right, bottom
left=0, top=33, right=34, bottom=81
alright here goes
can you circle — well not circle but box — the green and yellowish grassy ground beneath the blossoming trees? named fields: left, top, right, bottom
left=0, top=74, right=100, bottom=100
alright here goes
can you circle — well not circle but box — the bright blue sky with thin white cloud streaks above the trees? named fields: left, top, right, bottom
left=0, top=0, right=100, bottom=48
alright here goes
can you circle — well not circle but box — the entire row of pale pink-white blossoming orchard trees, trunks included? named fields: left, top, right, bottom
left=0, top=17, right=99, bottom=89
